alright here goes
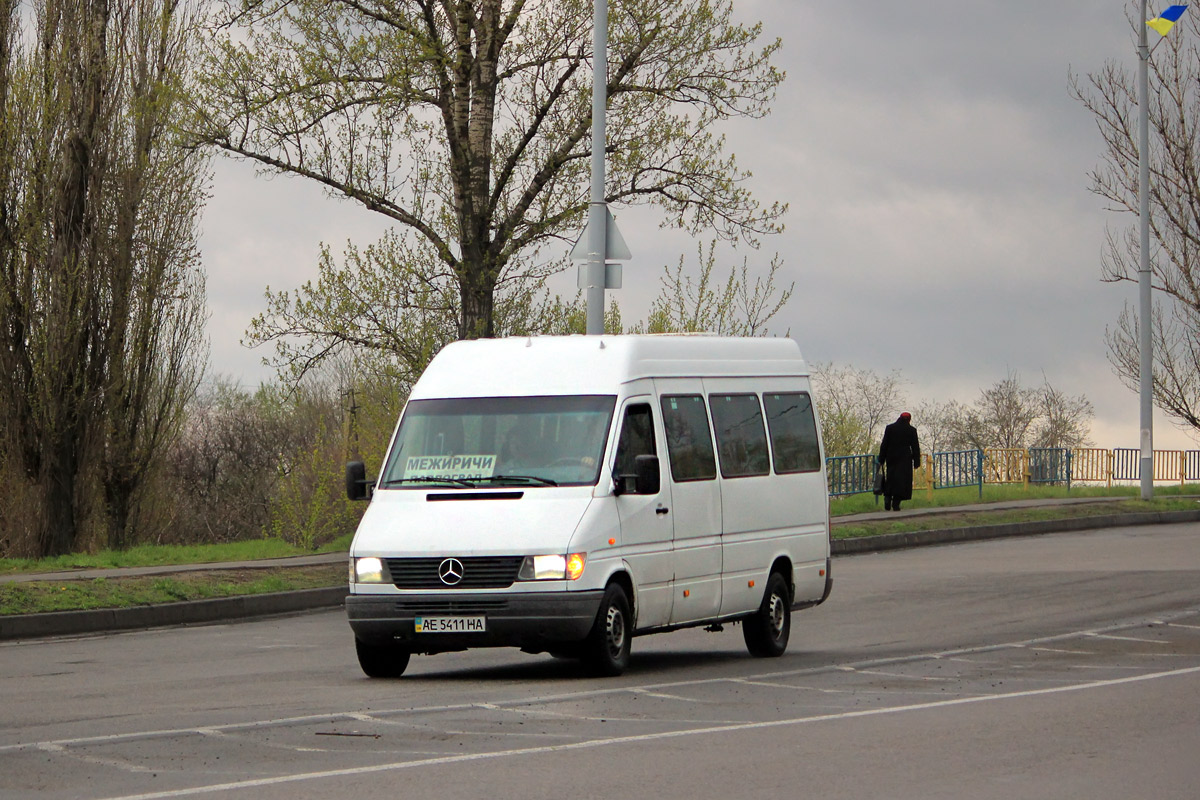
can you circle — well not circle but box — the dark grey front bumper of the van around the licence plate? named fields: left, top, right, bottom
left=346, top=590, right=604, bottom=652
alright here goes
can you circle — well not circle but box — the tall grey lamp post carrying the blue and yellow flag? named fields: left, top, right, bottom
left=1138, top=0, right=1154, bottom=500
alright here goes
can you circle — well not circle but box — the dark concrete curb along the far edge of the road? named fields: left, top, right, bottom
left=0, top=510, right=1200, bottom=640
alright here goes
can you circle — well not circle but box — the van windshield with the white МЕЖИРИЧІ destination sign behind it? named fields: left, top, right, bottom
left=378, top=395, right=617, bottom=488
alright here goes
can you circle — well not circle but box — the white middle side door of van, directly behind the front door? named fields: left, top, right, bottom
left=654, top=379, right=721, bottom=624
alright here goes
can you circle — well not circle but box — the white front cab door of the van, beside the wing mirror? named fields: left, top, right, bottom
left=612, top=393, right=674, bottom=628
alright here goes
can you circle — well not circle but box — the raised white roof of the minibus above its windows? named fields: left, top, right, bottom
left=412, top=333, right=809, bottom=399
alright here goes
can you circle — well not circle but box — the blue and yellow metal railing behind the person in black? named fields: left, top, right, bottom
left=826, top=447, right=1200, bottom=497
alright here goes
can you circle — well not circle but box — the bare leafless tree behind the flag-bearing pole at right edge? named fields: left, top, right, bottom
left=1072, top=2, right=1200, bottom=431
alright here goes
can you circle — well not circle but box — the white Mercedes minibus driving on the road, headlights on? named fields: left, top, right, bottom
left=346, top=335, right=833, bottom=678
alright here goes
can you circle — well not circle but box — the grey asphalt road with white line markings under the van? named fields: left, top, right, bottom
left=0, top=524, right=1200, bottom=800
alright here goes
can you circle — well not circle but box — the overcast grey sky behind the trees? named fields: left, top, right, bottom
left=194, top=0, right=1196, bottom=449
